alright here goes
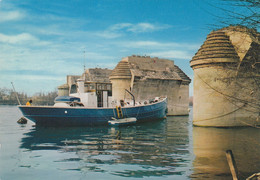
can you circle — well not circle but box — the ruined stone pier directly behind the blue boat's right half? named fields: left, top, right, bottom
left=109, top=55, right=191, bottom=115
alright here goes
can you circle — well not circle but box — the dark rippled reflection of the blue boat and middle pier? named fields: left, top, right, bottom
left=20, top=117, right=191, bottom=177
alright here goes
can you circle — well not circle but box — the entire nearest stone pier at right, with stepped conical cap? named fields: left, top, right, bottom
left=190, top=26, right=260, bottom=127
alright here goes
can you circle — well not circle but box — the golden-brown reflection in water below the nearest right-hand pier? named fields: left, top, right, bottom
left=191, top=127, right=260, bottom=179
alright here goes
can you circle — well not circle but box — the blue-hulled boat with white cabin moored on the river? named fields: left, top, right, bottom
left=18, top=80, right=167, bottom=126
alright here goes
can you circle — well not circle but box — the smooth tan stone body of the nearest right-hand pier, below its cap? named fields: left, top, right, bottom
left=193, top=66, right=259, bottom=127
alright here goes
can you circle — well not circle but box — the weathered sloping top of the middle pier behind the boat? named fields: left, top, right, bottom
left=109, top=55, right=191, bottom=83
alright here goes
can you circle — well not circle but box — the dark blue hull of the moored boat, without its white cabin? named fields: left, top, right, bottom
left=19, top=98, right=167, bottom=126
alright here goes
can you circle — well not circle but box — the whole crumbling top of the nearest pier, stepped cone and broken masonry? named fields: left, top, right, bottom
left=190, top=26, right=260, bottom=67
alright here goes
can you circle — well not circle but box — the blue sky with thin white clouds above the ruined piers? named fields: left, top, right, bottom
left=0, top=0, right=249, bottom=95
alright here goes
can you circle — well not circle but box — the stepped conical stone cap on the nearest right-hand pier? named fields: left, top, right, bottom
left=190, top=30, right=239, bottom=67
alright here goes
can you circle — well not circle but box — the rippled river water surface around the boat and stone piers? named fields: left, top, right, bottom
left=0, top=106, right=260, bottom=180
